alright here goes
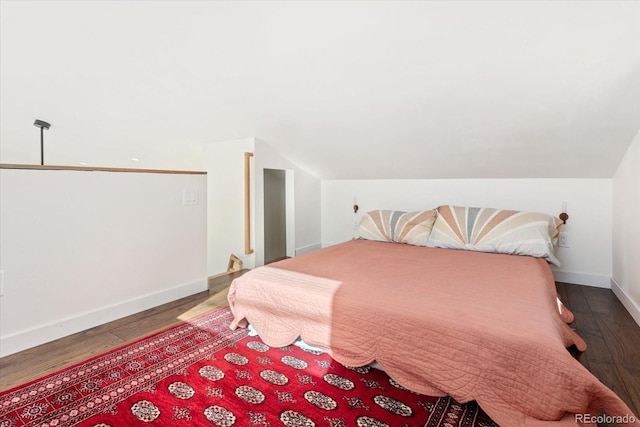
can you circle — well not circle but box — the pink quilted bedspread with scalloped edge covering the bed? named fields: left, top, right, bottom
left=229, top=240, right=640, bottom=427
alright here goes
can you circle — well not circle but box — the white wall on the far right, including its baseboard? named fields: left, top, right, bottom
left=612, top=132, right=640, bottom=325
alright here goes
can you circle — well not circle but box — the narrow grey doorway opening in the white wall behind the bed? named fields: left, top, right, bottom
left=263, top=169, right=287, bottom=264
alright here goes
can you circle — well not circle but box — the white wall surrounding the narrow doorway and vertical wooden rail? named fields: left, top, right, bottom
left=203, top=138, right=321, bottom=275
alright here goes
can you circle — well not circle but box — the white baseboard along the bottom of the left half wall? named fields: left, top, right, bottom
left=0, top=278, right=207, bottom=357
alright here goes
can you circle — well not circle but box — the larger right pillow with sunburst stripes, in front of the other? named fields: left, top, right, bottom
left=427, top=206, right=562, bottom=266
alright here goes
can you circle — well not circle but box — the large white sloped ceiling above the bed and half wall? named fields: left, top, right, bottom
left=0, top=1, right=640, bottom=179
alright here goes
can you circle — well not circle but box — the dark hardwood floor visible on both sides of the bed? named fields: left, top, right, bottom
left=0, top=278, right=640, bottom=424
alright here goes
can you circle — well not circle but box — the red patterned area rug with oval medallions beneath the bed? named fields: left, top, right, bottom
left=0, top=309, right=496, bottom=427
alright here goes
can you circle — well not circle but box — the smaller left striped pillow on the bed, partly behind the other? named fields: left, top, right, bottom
left=356, top=209, right=437, bottom=246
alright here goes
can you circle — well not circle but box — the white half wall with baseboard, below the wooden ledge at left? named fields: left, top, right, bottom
left=0, top=169, right=207, bottom=356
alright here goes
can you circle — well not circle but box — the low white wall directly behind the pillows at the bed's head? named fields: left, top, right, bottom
left=322, top=179, right=612, bottom=287
